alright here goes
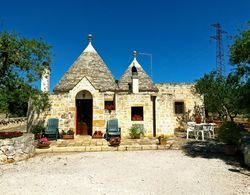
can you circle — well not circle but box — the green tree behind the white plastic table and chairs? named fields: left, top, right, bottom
left=195, top=72, right=243, bottom=121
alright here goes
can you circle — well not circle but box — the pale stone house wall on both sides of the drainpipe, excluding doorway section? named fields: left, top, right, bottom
left=114, top=84, right=203, bottom=136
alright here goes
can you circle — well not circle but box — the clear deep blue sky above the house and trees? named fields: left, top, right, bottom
left=0, top=0, right=250, bottom=89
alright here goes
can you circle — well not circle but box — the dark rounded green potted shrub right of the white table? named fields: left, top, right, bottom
left=218, top=121, right=244, bottom=145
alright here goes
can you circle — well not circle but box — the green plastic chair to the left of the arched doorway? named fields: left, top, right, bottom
left=44, top=118, right=59, bottom=140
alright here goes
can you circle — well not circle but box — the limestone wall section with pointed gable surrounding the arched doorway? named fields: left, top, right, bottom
left=40, top=77, right=106, bottom=133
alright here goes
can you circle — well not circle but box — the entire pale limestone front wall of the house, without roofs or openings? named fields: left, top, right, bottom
left=27, top=77, right=203, bottom=136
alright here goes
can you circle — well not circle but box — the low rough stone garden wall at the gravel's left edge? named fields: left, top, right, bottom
left=0, top=134, right=35, bottom=164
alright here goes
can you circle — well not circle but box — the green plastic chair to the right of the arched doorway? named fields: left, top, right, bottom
left=106, top=118, right=121, bottom=141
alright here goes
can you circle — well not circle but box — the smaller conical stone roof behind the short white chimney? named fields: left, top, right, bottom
left=118, top=53, right=158, bottom=92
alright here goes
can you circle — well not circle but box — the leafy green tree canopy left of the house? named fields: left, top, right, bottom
left=0, top=32, right=51, bottom=116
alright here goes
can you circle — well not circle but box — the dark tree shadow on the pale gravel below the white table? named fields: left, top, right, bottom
left=181, top=140, right=249, bottom=172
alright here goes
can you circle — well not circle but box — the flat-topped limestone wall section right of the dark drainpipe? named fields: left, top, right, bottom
left=156, top=83, right=203, bottom=134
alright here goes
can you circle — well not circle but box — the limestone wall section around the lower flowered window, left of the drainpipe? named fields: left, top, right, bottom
left=116, top=92, right=153, bottom=136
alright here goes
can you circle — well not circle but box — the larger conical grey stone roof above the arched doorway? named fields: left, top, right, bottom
left=54, top=35, right=117, bottom=93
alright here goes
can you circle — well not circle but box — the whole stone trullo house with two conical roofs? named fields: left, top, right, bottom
left=31, top=36, right=203, bottom=136
